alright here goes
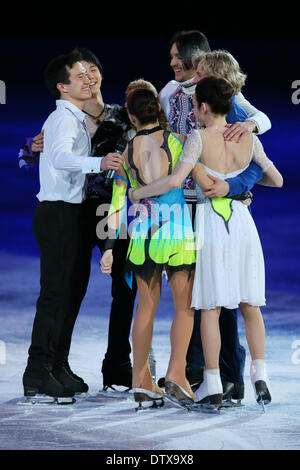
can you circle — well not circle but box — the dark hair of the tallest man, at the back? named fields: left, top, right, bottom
left=170, top=30, right=211, bottom=70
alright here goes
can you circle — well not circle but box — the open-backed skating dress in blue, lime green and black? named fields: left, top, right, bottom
left=109, top=129, right=196, bottom=283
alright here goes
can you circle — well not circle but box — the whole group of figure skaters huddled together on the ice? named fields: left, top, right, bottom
left=20, top=30, right=283, bottom=409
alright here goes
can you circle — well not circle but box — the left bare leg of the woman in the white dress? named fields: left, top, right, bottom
left=201, top=307, right=221, bottom=369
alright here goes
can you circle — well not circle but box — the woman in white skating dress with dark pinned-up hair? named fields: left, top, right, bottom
left=130, top=77, right=283, bottom=407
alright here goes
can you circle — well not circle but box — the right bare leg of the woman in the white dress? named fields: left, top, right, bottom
left=240, top=303, right=265, bottom=360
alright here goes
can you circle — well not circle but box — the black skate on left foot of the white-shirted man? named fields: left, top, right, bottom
left=23, top=366, right=75, bottom=405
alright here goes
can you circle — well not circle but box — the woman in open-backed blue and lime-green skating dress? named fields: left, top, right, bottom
left=100, top=89, right=196, bottom=405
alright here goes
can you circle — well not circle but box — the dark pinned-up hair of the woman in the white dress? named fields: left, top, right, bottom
left=195, top=77, right=234, bottom=115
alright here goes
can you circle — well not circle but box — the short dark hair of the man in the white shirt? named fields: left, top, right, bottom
left=44, top=52, right=80, bottom=99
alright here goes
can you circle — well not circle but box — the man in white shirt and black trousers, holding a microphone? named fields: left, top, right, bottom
left=23, top=53, right=122, bottom=398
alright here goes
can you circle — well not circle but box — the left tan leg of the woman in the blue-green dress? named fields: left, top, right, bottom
left=132, top=276, right=161, bottom=391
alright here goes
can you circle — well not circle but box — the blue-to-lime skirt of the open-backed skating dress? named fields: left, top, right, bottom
left=126, top=188, right=196, bottom=283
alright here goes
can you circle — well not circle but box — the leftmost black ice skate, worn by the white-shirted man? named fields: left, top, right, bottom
left=23, top=373, right=76, bottom=405
